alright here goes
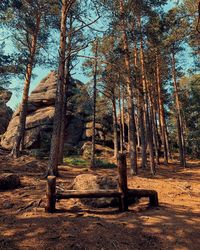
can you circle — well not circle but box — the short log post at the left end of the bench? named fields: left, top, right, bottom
left=45, top=176, right=56, bottom=213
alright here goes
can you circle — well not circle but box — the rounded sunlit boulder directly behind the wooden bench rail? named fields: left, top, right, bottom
left=71, top=174, right=118, bottom=207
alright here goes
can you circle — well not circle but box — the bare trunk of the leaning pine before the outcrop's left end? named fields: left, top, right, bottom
left=11, top=15, right=41, bottom=158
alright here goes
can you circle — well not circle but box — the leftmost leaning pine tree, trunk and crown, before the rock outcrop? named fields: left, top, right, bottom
left=10, top=0, right=55, bottom=157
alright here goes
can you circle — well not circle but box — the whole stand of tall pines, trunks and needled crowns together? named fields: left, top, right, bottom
left=0, top=0, right=200, bottom=174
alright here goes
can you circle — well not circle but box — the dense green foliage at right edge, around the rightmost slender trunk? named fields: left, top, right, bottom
left=168, top=75, right=200, bottom=158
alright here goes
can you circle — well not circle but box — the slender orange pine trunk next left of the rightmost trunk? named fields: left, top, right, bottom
left=156, top=50, right=168, bottom=164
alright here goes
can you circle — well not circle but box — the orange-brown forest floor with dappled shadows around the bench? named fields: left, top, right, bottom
left=0, top=153, right=200, bottom=250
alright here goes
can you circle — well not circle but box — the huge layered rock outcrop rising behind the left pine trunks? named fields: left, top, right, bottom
left=1, top=72, right=91, bottom=149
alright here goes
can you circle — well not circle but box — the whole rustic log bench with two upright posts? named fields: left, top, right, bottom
left=45, top=154, right=158, bottom=213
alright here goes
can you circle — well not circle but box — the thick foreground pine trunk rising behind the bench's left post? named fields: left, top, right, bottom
left=47, top=0, right=69, bottom=176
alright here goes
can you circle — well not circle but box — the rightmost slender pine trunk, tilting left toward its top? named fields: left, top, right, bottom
left=172, top=48, right=186, bottom=167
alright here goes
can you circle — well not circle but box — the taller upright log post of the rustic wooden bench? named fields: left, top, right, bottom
left=117, top=154, right=128, bottom=212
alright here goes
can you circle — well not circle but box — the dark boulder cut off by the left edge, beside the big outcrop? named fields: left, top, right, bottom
left=0, top=87, right=12, bottom=135
